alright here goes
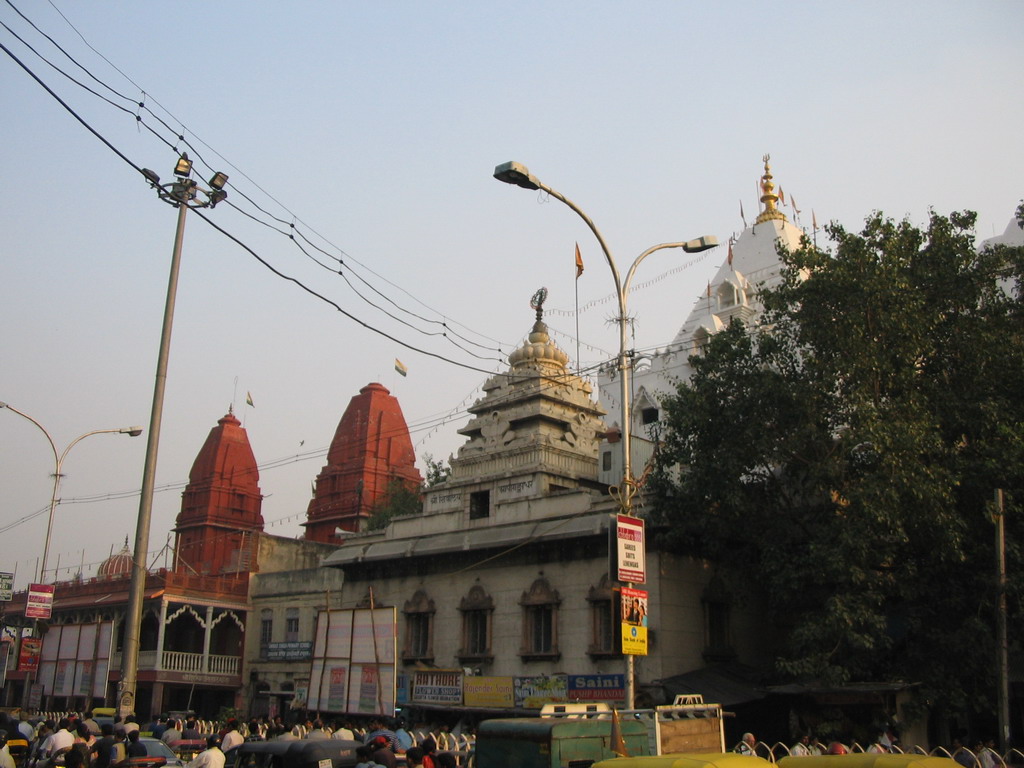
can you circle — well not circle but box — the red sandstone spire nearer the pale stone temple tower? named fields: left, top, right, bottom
left=303, top=383, right=423, bottom=544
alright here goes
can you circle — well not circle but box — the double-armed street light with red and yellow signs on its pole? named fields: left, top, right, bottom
left=495, top=162, right=718, bottom=709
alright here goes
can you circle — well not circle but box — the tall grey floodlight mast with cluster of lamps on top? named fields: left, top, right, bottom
left=118, top=153, right=227, bottom=717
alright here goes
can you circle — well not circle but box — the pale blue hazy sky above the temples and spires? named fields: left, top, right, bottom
left=0, top=0, right=1024, bottom=588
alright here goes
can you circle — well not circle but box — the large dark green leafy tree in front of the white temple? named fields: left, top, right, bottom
left=651, top=208, right=1024, bottom=712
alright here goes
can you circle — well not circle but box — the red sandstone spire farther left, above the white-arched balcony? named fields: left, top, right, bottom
left=174, top=411, right=263, bottom=575
